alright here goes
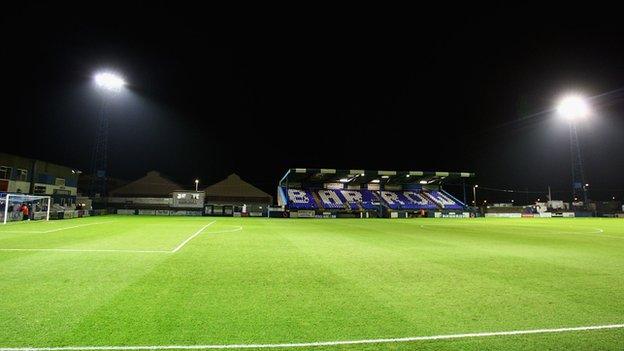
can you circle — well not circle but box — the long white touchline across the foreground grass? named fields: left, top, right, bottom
left=0, top=324, right=624, bottom=351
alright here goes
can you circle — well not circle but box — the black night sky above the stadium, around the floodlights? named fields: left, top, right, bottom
left=0, top=3, right=624, bottom=204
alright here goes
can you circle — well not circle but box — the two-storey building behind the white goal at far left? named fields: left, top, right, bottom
left=0, top=153, right=80, bottom=206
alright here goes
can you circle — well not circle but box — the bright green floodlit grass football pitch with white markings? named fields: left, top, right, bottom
left=0, top=216, right=624, bottom=351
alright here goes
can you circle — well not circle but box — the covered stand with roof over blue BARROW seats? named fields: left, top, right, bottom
left=278, top=168, right=474, bottom=217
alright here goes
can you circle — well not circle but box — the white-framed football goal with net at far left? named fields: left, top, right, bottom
left=0, top=194, right=51, bottom=224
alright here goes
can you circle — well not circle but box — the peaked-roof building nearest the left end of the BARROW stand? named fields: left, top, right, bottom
left=204, top=174, right=273, bottom=216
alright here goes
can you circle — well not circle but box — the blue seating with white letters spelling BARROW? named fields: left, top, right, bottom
left=285, top=188, right=464, bottom=211
